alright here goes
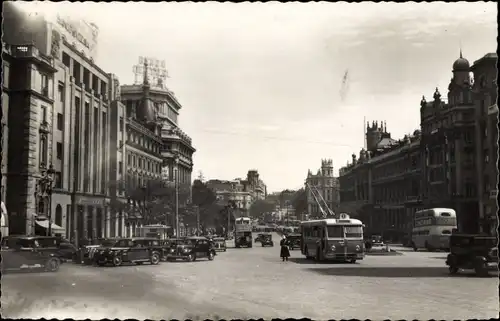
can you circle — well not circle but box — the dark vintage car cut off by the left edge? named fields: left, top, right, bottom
left=1, top=235, right=62, bottom=272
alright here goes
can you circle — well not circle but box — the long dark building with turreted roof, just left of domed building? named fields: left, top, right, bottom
left=339, top=122, right=421, bottom=235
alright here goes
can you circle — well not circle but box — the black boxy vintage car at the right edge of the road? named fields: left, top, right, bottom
left=446, top=234, right=498, bottom=276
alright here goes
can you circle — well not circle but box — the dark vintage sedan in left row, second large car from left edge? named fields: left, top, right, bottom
left=93, top=237, right=162, bottom=266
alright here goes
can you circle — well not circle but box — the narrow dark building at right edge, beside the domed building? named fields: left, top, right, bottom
left=471, top=53, right=498, bottom=234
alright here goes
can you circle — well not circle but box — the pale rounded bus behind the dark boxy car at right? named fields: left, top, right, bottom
left=411, top=208, right=457, bottom=252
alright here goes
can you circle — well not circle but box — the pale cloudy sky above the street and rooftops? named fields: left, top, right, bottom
left=17, top=2, right=497, bottom=192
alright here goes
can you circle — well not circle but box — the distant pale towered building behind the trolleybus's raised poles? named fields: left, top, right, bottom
left=305, top=159, right=339, bottom=217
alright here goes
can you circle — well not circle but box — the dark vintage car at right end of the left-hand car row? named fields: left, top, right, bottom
left=167, top=236, right=216, bottom=262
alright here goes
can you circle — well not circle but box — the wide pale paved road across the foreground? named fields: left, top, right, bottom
left=1, top=234, right=499, bottom=320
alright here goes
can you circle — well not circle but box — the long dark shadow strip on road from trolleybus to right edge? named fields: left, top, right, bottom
left=309, top=266, right=498, bottom=278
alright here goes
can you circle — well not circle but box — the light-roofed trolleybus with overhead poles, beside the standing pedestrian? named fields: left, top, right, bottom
left=300, top=213, right=365, bottom=263
